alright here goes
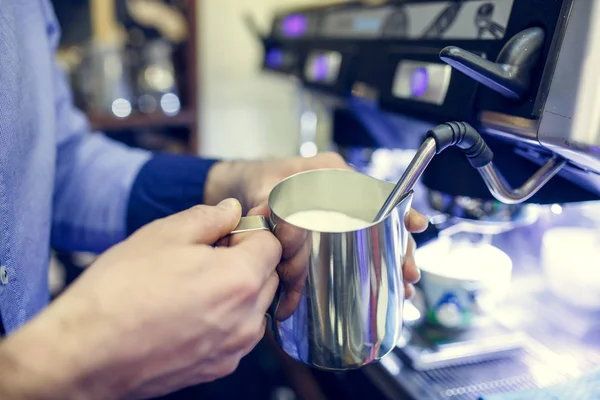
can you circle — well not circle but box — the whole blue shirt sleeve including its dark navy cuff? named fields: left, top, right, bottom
left=44, top=3, right=216, bottom=253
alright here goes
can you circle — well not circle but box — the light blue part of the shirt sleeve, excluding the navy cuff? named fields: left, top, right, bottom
left=42, top=2, right=152, bottom=253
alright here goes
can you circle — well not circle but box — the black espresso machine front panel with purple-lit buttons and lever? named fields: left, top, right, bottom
left=264, top=0, right=572, bottom=122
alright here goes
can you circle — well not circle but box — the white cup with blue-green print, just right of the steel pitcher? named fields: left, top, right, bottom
left=415, top=238, right=512, bottom=329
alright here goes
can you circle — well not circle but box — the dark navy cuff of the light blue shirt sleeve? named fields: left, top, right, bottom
left=127, top=154, right=219, bottom=235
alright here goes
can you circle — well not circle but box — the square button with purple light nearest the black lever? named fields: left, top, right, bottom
left=392, top=60, right=452, bottom=105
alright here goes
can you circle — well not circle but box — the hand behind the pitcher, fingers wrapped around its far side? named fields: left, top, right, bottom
left=205, top=153, right=428, bottom=310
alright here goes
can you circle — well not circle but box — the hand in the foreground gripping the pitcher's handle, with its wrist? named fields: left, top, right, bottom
left=0, top=200, right=281, bottom=400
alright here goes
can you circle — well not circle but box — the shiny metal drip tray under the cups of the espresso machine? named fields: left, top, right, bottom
left=365, top=277, right=600, bottom=400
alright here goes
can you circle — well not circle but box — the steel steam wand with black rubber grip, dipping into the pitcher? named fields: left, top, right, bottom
left=374, top=122, right=567, bottom=222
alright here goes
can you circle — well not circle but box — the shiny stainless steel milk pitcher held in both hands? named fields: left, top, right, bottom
left=233, top=169, right=412, bottom=370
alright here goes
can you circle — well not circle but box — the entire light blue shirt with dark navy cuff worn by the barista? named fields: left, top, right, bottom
left=0, top=0, right=214, bottom=331
